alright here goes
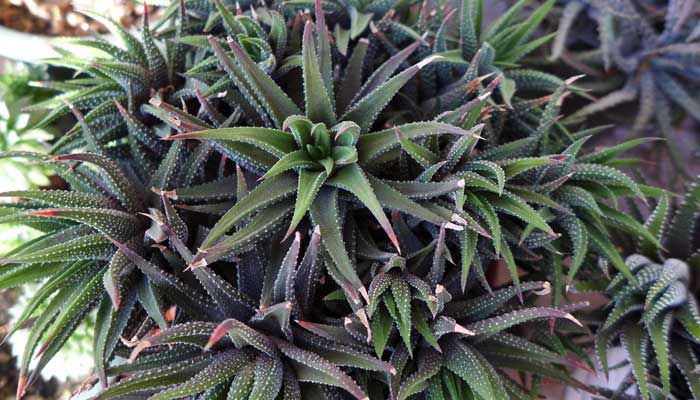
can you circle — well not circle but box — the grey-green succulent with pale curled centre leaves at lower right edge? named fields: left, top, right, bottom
left=596, top=181, right=700, bottom=399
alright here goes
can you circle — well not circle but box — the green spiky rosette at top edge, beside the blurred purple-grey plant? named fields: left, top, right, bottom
left=418, top=0, right=561, bottom=112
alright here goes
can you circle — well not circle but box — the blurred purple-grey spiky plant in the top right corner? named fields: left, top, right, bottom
left=552, top=0, right=700, bottom=165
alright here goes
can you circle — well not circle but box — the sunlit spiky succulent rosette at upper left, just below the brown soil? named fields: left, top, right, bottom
left=26, top=3, right=194, bottom=159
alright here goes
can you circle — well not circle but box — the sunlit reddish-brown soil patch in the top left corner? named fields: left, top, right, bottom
left=0, top=0, right=143, bottom=36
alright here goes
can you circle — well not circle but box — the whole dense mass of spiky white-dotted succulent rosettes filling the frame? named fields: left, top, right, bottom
left=0, top=0, right=700, bottom=400
